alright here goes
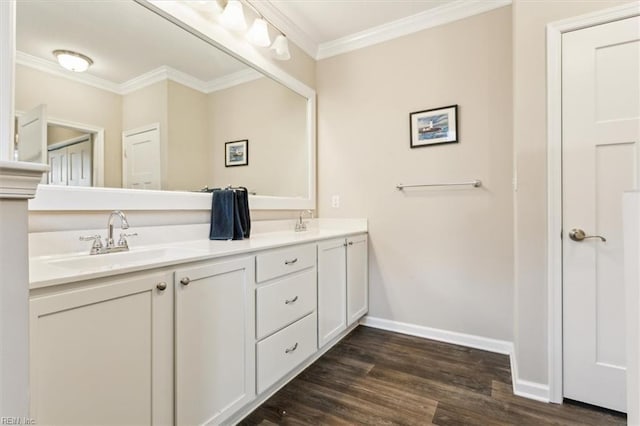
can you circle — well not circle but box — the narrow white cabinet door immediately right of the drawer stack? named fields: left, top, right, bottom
left=318, top=238, right=347, bottom=347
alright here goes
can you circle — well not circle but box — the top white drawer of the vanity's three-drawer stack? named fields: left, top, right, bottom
left=256, top=244, right=316, bottom=283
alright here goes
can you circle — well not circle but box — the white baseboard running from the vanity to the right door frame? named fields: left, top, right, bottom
left=360, top=316, right=549, bottom=402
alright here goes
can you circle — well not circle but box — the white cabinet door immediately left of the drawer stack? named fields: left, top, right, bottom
left=175, top=257, right=255, bottom=425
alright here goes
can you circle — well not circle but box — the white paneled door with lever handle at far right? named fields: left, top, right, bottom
left=562, top=17, right=640, bottom=411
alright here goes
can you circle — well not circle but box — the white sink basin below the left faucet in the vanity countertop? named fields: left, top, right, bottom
left=46, top=247, right=200, bottom=270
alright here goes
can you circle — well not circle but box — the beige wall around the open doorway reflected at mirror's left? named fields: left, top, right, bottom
left=15, top=65, right=122, bottom=187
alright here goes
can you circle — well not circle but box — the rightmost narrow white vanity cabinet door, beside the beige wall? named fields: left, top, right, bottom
left=347, top=235, right=369, bottom=325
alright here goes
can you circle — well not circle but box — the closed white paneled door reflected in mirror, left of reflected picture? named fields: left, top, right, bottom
left=122, top=124, right=161, bottom=189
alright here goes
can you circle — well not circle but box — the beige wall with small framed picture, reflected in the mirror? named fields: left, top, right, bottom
left=208, top=78, right=308, bottom=197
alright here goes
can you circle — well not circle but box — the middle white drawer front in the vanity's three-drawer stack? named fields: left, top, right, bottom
left=256, top=268, right=317, bottom=339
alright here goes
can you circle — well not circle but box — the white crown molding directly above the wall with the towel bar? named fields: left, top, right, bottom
left=316, top=0, right=511, bottom=60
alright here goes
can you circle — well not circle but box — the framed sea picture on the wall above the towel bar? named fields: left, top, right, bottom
left=409, top=105, right=458, bottom=148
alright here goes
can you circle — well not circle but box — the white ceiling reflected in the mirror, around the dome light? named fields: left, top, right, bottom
left=16, top=0, right=247, bottom=84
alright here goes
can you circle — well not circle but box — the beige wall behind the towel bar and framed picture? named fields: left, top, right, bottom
left=317, top=7, right=513, bottom=341
